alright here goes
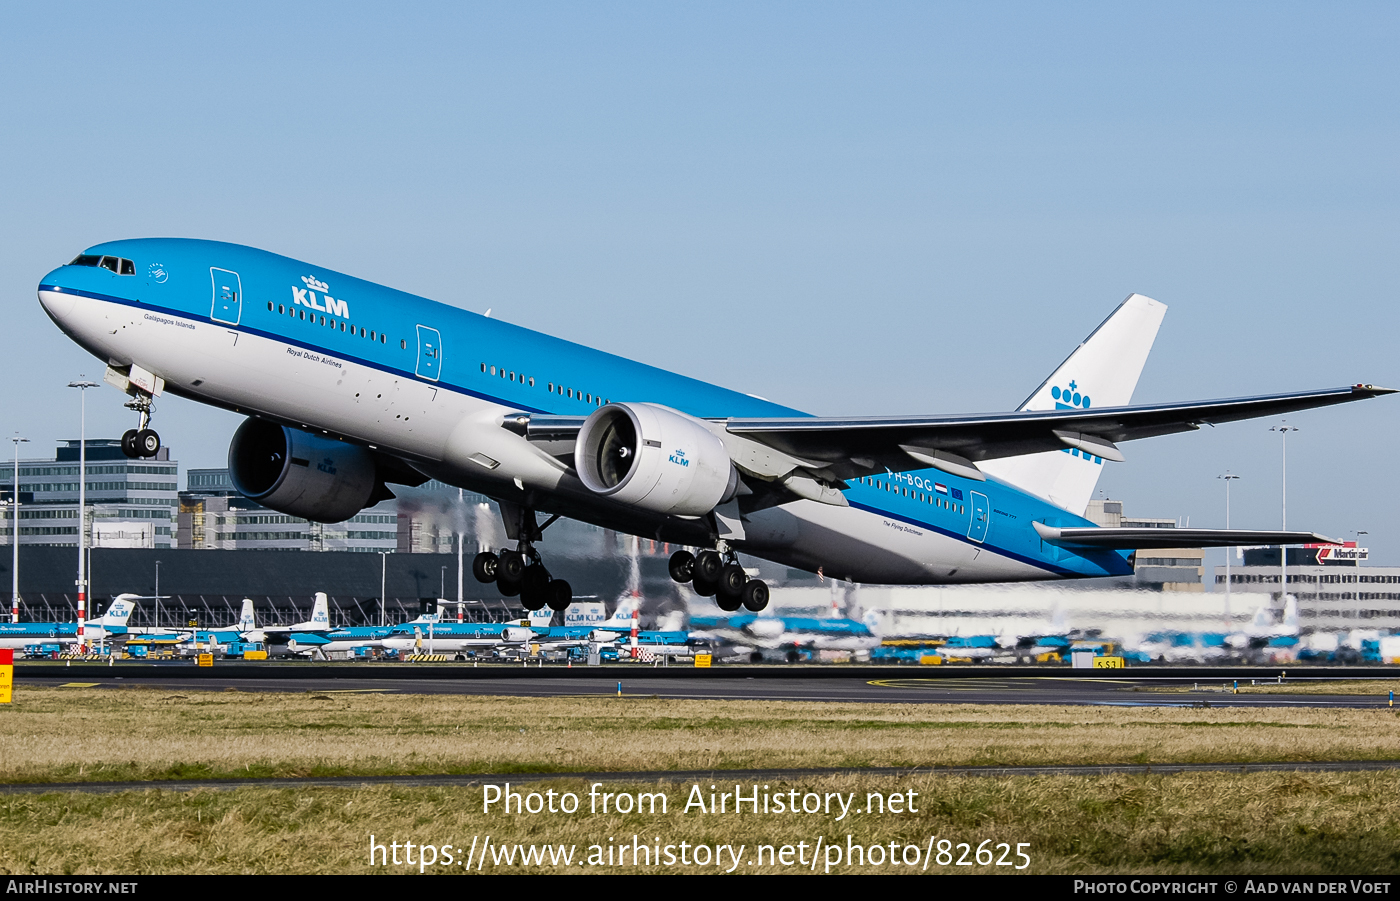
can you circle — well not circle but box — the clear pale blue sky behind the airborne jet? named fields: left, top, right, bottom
left=0, top=3, right=1400, bottom=562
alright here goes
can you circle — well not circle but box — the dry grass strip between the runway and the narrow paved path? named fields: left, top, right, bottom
left=0, top=687, right=1400, bottom=782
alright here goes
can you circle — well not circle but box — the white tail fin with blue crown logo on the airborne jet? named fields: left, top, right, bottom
left=979, top=294, right=1166, bottom=515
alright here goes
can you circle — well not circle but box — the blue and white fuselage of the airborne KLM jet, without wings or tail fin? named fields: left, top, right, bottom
left=39, top=239, right=1131, bottom=583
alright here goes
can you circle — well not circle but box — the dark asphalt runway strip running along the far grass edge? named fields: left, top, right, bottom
left=15, top=667, right=1394, bottom=708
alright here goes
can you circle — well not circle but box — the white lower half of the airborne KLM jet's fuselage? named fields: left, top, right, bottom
left=39, top=291, right=1058, bottom=585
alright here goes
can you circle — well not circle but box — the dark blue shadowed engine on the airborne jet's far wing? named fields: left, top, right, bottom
left=228, top=420, right=377, bottom=522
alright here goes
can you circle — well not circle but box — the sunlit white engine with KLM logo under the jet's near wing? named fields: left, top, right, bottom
left=574, top=403, right=739, bottom=516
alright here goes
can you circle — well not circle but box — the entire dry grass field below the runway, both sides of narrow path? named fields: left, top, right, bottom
left=0, top=686, right=1400, bottom=874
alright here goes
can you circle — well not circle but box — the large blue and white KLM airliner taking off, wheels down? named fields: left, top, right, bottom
left=39, top=238, right=1392, bottom=611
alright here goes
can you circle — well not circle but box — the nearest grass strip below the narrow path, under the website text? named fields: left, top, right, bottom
left=0, top=772, right=1400, bottom=876
